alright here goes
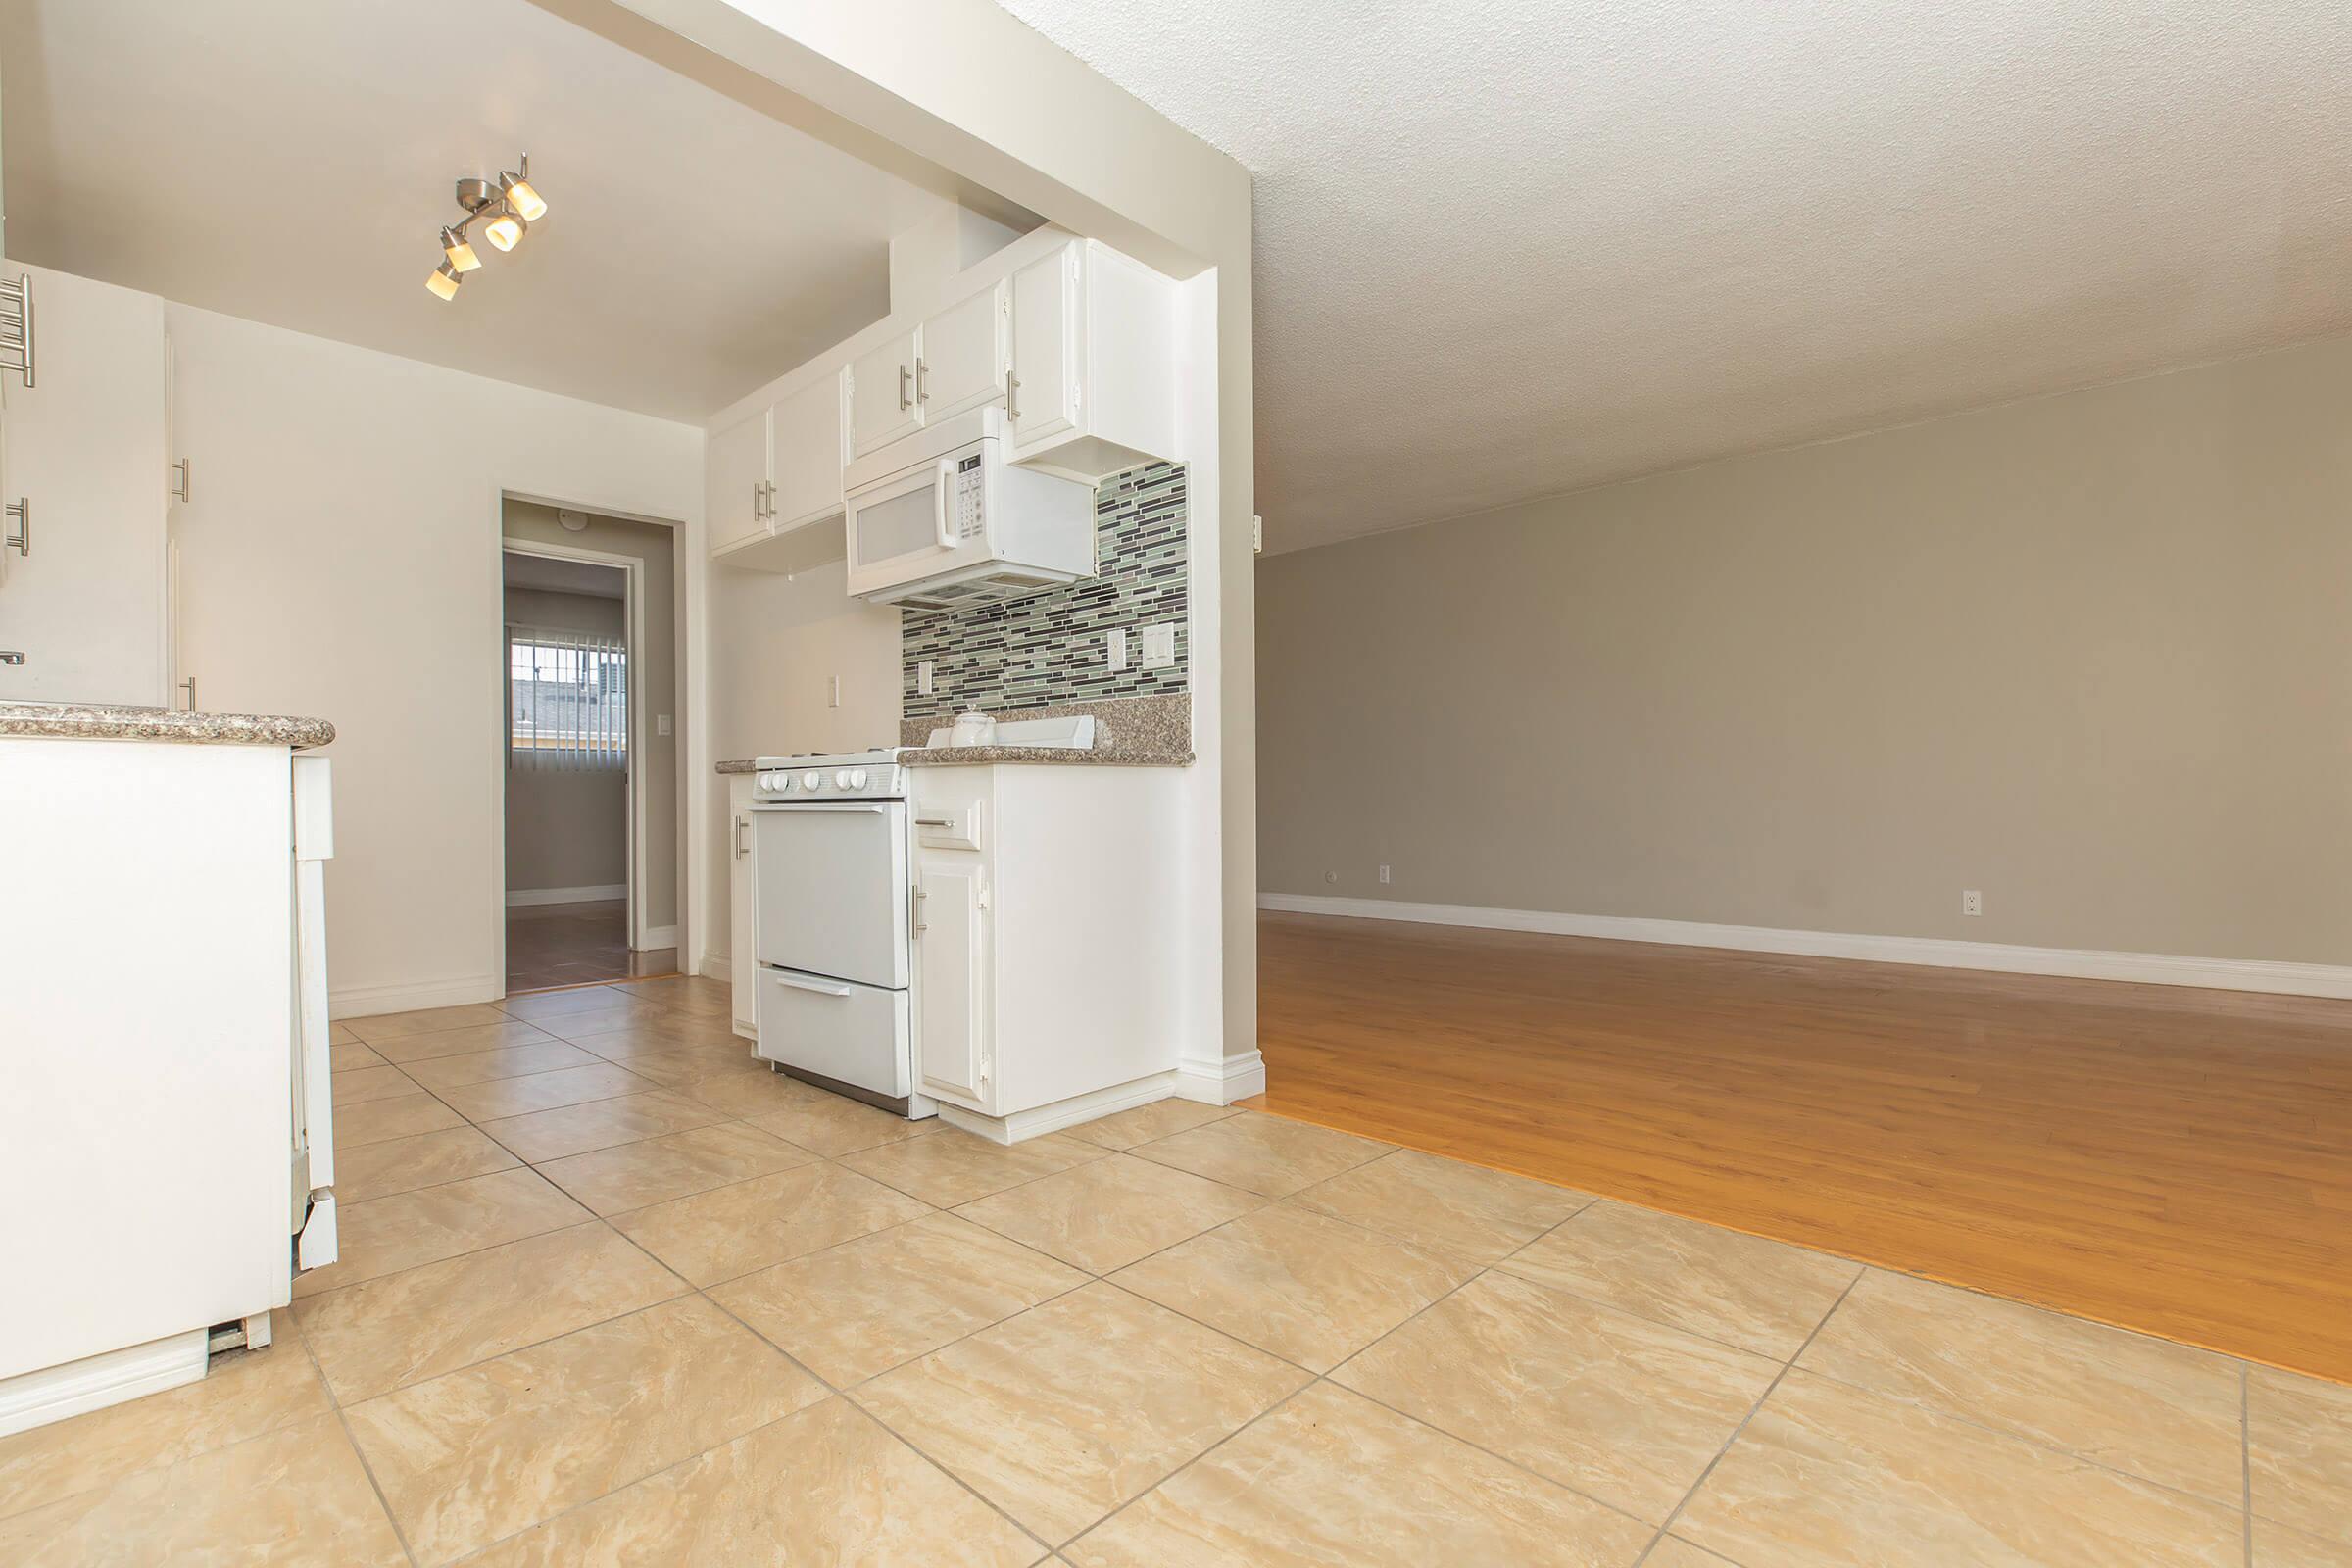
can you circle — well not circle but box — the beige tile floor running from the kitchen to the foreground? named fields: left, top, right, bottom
left=0, top=978, right=2352, bottom=1568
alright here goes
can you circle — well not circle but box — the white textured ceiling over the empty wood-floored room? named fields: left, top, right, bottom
left=1002, top=0, right=2352, bottom=550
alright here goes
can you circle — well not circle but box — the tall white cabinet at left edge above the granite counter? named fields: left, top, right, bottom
left=0, top=264, right=170, bottom=708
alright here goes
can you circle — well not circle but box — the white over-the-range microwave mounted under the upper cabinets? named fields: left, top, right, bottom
left=845, top=407, right=1094, bottom=609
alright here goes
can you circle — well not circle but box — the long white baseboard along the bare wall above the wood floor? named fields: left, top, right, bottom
left=1258, top=894, right=2352, bottom=997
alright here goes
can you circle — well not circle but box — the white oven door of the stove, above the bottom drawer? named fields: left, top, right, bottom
left=751, top=800, right=907, bottom=999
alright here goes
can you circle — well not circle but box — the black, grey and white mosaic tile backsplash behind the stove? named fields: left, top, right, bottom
left=899, top=464, right=1193, bottom=719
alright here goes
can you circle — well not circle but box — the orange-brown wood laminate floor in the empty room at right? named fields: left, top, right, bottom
left=1253, top=914, right=2352, bottom=1382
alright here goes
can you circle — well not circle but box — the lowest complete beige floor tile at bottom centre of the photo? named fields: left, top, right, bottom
left=852, top=1288, right=1307, bottom=1543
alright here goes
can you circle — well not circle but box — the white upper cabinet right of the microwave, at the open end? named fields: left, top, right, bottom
left=1006, top=240, right=1176, bottom=484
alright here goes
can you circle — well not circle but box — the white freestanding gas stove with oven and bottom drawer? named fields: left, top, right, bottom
left=751, top=748, right=936, bottom=1116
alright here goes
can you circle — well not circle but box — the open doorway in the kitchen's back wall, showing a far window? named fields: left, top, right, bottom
left=499, top=501, right=677, bottom=995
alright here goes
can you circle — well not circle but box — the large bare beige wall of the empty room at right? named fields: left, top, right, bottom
left=1258, top=341, right=2352, bottom=964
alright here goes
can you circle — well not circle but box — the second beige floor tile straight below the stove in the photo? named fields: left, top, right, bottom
left=612, top=1163, right=931, bottom=1286
